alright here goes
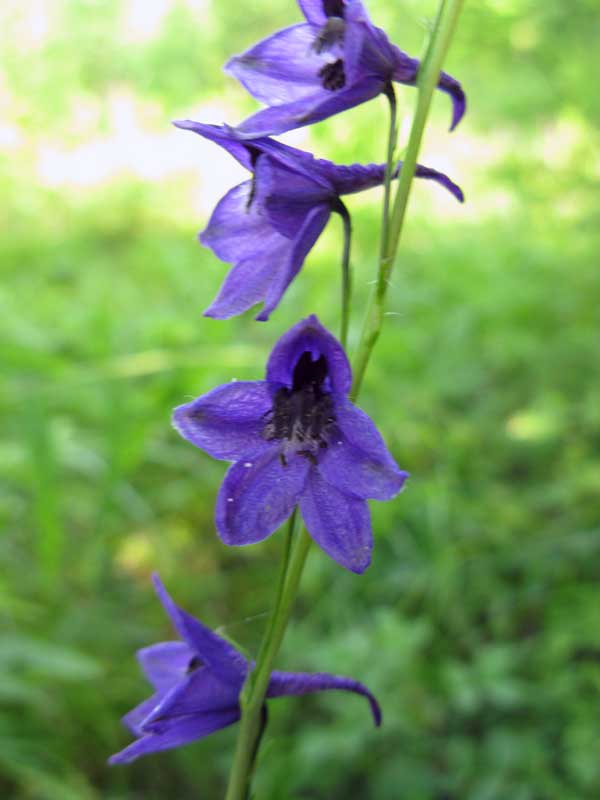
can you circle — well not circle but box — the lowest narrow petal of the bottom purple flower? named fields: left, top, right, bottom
left=108, top=709, right=240, bottom=764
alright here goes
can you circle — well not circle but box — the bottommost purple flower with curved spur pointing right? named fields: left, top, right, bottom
left=109, top=575, right=381, bottom=764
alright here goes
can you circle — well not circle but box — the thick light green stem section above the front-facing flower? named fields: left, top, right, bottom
left=351, top=0, right=464, bottom=399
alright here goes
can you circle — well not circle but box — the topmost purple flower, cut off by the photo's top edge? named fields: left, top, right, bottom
left=225, top=0, right=466, bottom=137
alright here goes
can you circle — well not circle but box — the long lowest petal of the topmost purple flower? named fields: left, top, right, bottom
left=235, top=75, right=384, bottom=139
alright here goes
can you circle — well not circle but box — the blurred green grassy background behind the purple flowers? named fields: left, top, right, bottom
left=0, top=0, right=600, bottom=800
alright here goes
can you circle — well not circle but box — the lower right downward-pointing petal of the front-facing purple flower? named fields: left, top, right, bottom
left=300, top=469, right=373, bottom=574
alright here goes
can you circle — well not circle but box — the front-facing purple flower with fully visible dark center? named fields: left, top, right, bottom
left=173, top=316, right=407, bottom=573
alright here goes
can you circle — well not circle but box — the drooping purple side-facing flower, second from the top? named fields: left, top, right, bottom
left=175, top=120, right=463, bottom=320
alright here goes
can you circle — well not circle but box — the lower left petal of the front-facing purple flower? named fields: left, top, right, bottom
left=215, top=446, right=309, bottom=546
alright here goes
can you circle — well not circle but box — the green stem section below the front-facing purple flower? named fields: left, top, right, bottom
left=225, top=511, right=312, bottom=800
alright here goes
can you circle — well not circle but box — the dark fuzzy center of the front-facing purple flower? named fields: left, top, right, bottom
left=263, top=352, right=335, bottom=466
